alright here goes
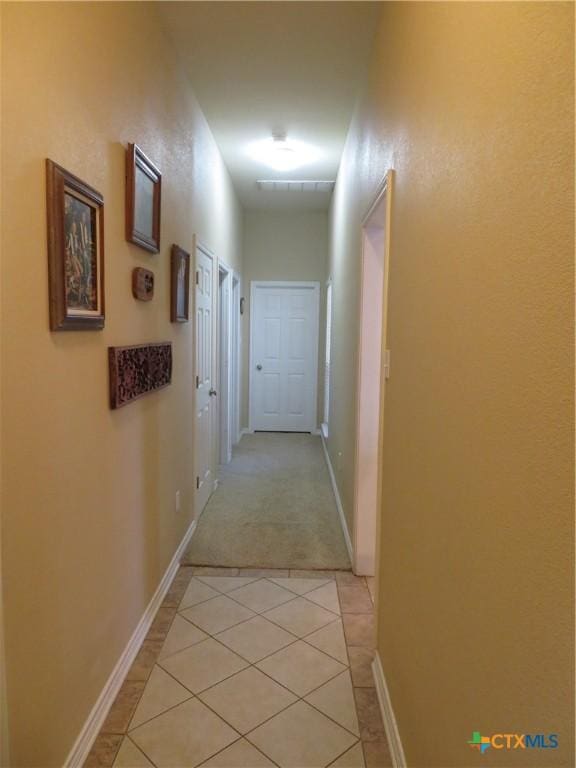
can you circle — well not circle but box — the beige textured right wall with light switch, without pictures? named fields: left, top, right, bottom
left=330, top=2, right=574, bottom=768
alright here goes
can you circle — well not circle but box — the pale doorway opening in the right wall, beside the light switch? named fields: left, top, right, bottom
left=353, top=171, right=393, bottom=576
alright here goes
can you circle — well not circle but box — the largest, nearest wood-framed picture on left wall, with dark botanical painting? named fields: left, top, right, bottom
left=46, top=160, right=104, bottom=331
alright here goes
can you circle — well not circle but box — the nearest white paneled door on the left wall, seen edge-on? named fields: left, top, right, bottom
left=195, top=246, right=216, bottom=514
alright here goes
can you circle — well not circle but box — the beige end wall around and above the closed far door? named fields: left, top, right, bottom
left=242, top=211, right=328, bottom=427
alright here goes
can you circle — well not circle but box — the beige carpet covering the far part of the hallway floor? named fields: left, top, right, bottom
left=183, top=432, right=350, bottom=570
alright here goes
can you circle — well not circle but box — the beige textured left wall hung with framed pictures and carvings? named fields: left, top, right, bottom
left=1, top=3, right=242, bottom=768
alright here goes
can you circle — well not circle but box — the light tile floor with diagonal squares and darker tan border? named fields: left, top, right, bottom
left=85, top=567, right=392, bottom=768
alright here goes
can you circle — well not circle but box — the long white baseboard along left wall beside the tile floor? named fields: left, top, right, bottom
left=64, top=520, right=197, bottom=768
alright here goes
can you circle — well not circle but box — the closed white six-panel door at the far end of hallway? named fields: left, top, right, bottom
left=250, top=283, right=320, bottom=432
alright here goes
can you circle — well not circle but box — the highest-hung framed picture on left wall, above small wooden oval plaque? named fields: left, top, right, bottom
left=126, top=144, right=162, bottom=253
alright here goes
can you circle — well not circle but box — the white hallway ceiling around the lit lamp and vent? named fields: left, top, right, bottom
left=159, top=0, right=380, bottom=209
